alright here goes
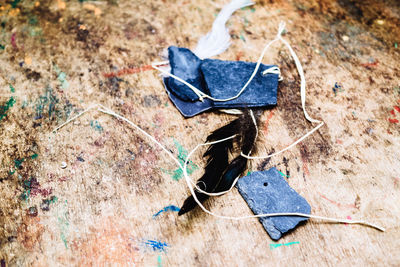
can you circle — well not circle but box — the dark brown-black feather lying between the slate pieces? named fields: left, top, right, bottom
left=178, top=110, right=258, bottom=215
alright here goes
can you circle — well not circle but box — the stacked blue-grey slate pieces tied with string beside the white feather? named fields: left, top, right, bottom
left=164, top=46, right=279, bottom=117
